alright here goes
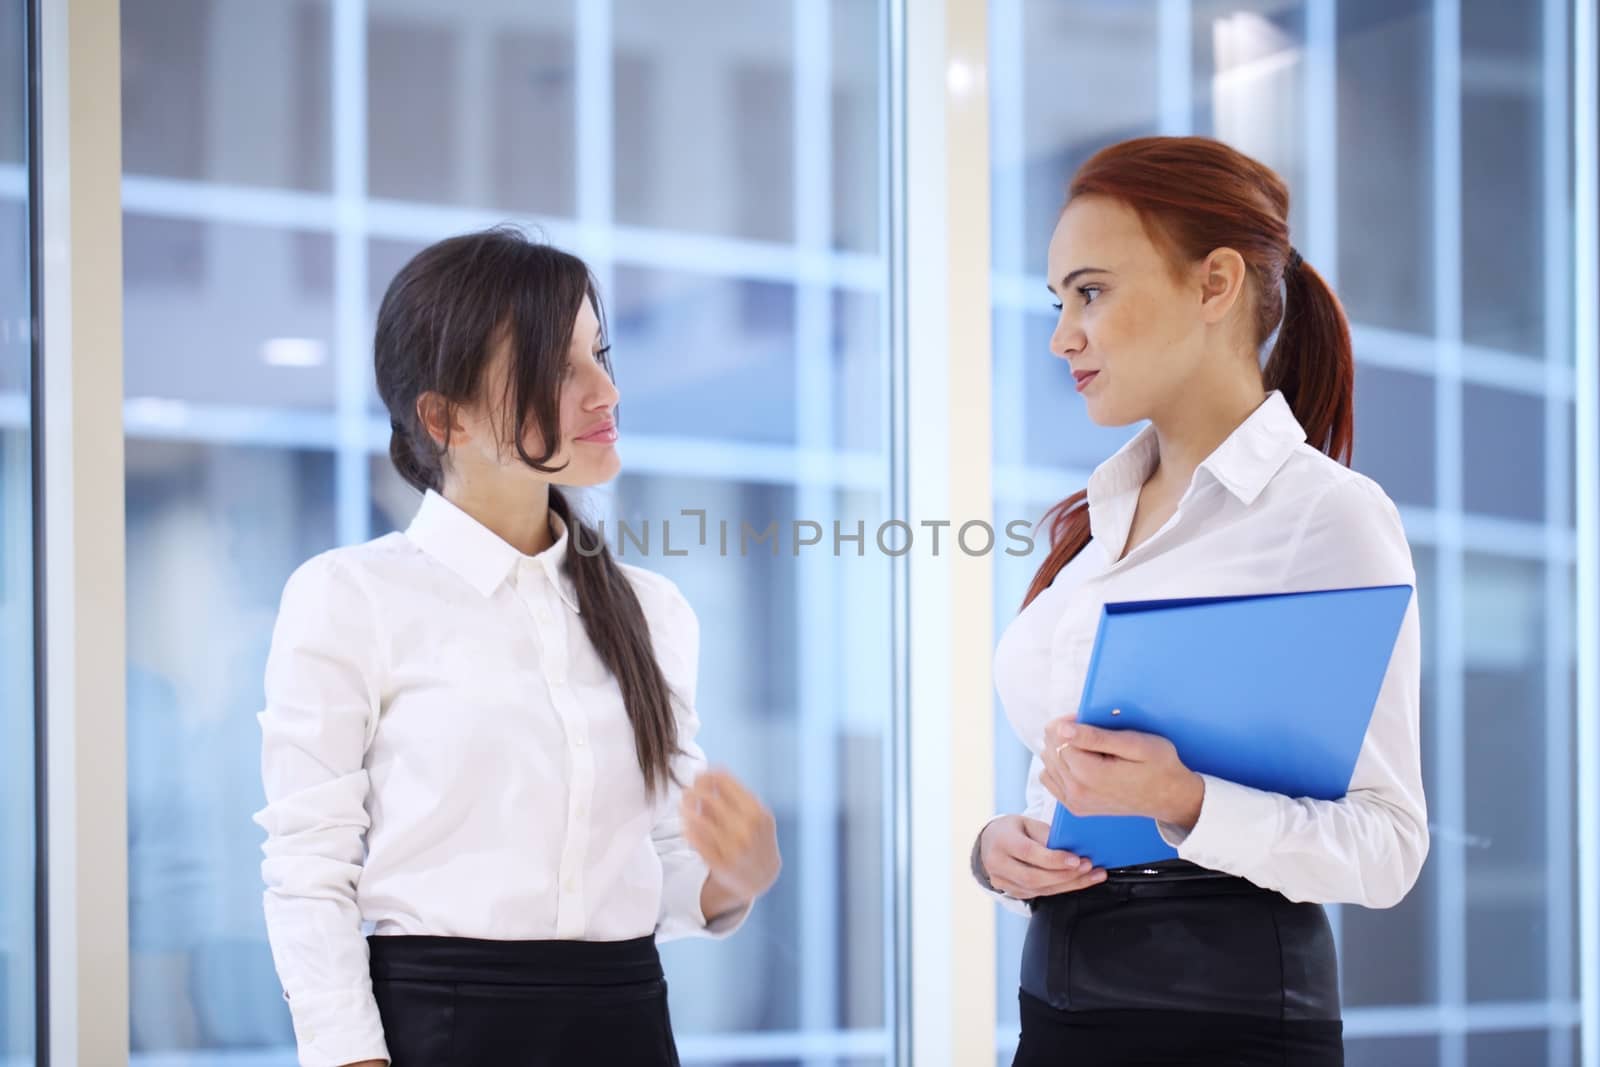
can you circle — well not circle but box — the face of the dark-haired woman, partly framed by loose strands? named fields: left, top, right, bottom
left=450, top=299, right=622, bottom=486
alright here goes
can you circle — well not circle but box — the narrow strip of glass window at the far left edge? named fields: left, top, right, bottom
left=0, top=0, right=37, bottom=1067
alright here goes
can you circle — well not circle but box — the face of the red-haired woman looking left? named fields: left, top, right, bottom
left=1046, top=195, right=1208, bottom=426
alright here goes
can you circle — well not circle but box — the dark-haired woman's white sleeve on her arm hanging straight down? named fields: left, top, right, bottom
left=254, top=553, right=389, bottom=1067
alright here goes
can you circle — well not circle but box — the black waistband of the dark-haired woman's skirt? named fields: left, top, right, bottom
left=366, top=934, right=662, bottom=985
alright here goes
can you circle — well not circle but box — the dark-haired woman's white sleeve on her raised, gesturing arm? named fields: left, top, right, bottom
left=637, top=571, right=752, bottom=942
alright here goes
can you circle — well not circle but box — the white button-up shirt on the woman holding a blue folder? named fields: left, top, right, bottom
left=995, top=392, right=1427, bottom=912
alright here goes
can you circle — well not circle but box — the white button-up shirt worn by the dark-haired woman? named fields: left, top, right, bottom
left=256, top=493, right=747, bottom=1067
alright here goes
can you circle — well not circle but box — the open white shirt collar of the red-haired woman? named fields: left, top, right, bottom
left=1088, top=389, right=1306, bottom=525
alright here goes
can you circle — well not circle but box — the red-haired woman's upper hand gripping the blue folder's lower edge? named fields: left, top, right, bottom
left=1040, top=717, right=1205, bottom=832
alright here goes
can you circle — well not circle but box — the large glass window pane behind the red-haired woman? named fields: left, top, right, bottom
left=989, top=0, right=1576, bottom=1064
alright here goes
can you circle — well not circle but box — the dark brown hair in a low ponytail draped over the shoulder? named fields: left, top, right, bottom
left=373, top=227, right=678, bottom=792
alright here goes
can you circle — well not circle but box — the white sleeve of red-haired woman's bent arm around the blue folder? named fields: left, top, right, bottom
left=1162, top=477, right=1429, bottom=907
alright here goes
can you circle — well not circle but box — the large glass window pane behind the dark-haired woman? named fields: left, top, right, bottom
left=123, top=0, right=894, bottom=1064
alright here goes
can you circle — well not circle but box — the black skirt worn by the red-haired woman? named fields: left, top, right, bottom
left=1013, top=862, right=1344, bottom=1067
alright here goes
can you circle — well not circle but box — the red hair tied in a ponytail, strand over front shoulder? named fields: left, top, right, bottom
left=1022, top=138, right=1355, bottom=608
